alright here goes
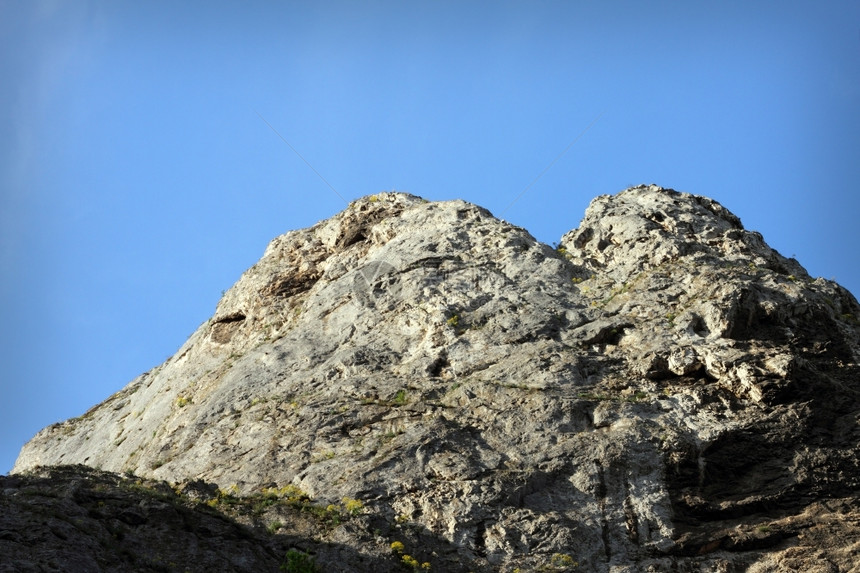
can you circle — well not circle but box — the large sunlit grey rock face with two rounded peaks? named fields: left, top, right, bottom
left=8, top=185, right=860, bottom=572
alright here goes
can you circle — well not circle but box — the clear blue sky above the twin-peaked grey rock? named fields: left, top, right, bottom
left=0, top=0, right=860, bottom=472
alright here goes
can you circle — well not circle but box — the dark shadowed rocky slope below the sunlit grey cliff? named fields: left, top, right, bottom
left=0, top=466, right=402, bottom=573
